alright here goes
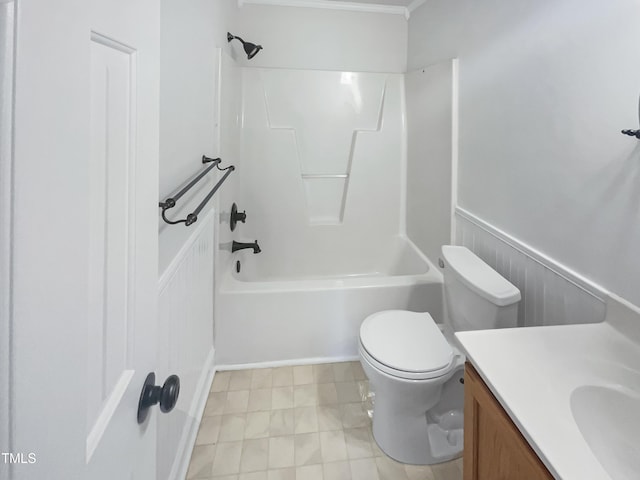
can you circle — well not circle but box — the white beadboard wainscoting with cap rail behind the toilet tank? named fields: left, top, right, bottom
left=455, top=207, right=607, bottom=327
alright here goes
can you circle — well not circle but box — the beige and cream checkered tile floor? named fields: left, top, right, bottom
left=187, top=362, right=462, bottom=480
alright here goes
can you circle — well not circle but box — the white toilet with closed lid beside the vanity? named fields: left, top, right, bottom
left=359, top=245, right=520, bottom=465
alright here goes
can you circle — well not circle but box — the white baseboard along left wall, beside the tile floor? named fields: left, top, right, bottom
left=169, top=347, right=216, bottom=480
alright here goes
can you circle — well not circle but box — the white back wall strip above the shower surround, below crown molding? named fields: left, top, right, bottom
left=232, top=5, right=407, bottom=73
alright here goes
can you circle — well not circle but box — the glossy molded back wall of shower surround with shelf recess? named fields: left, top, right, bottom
left=239, top=68, right=404, bottom=275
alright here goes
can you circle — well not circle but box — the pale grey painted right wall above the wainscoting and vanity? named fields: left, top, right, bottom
left=408, top=0, right=640, bottom=304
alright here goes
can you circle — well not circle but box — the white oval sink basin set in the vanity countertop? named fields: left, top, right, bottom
left=570, top=385, right=640, bottom=480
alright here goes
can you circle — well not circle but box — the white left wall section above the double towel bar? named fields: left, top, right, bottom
left=160, top=0, right=237, bottom=198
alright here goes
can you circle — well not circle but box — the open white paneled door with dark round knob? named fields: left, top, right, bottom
left=10, top=0, right=164, bottom=480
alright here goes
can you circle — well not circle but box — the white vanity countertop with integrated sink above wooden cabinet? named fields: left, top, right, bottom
left=457, top=296, right=640, bottom=480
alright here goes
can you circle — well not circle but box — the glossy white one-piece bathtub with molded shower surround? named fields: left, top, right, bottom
left=216, top=65, right=442, bottom=365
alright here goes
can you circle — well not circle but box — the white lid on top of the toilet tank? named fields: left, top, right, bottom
left=442, top=245, right=520, bottom=307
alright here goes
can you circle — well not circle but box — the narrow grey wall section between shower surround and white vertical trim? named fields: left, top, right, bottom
left=405, top=60, right=457, bottom=262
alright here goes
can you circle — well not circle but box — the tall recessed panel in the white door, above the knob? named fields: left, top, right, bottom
left=87, top=34, right=136, bottom=458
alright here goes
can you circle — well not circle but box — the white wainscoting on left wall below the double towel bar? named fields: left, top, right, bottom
left=156, top=209, right=216, bottom=480
